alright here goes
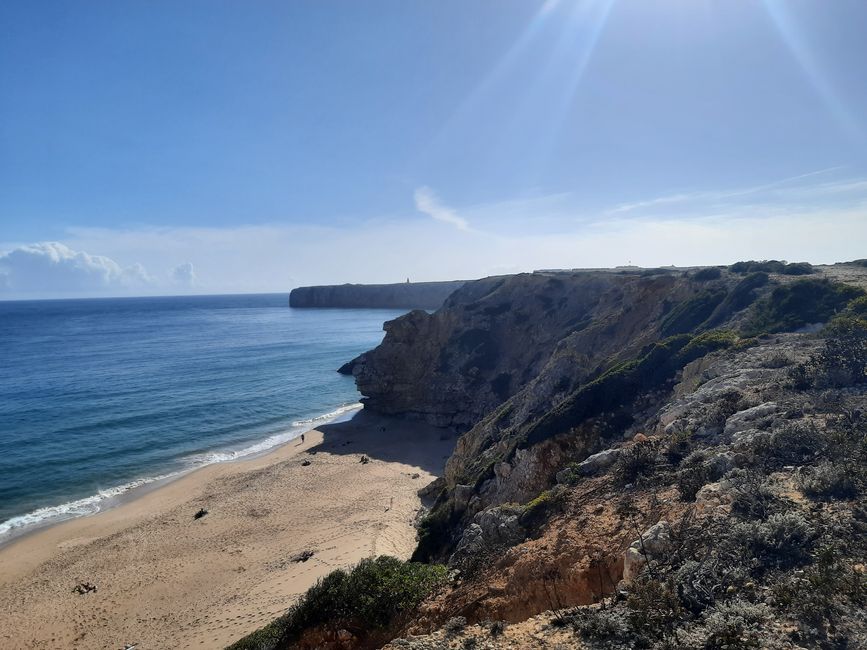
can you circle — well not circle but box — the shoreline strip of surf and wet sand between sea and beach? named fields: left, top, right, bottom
left=0, top=402, right=363, bottom=549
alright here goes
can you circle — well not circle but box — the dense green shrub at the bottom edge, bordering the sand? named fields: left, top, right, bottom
left=229, top=555, right=447, bottom=650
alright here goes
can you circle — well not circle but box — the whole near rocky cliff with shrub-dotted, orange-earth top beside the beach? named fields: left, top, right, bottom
left=234, top=261, right=867, bottom=650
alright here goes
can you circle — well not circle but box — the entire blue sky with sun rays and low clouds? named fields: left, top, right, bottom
left=0, top=0, right=867, bottom=297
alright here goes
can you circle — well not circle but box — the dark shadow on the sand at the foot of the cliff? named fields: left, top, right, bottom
left=310, top=410, right=457, bottom=476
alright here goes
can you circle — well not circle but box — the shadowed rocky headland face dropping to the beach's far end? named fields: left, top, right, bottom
left=345, top=272, right=752, bottom=430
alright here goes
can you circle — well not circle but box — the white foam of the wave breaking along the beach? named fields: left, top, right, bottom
left=0, top=403, right=362, bottom=541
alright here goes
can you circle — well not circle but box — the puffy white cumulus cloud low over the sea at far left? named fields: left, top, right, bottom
left=0, top=242, right=153, bottom=295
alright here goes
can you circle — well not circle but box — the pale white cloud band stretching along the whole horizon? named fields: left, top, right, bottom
left=0, top=170, right=867, bottom=297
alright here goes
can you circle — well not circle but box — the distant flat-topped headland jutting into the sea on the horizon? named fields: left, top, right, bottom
left=289, top=281, right=464, bottom=309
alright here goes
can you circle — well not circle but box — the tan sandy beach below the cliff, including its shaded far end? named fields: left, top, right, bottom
left=0, top=411, right=454, bottom=650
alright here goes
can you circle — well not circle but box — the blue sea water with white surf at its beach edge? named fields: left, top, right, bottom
left=0, top=294, right=402, bottom=542
